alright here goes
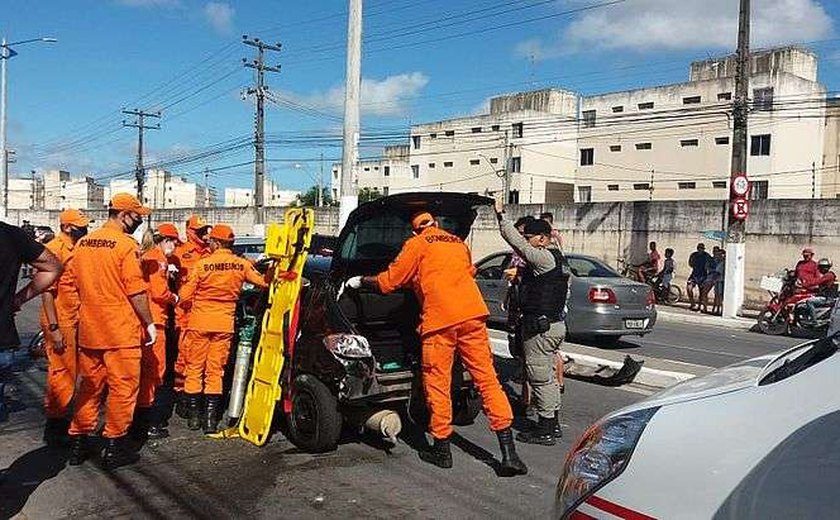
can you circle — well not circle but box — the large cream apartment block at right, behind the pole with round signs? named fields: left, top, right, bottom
left=575, top=47, right=836, bottom=202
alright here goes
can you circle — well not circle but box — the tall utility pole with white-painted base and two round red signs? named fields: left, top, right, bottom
left=723, top=0, right=752, bottom=318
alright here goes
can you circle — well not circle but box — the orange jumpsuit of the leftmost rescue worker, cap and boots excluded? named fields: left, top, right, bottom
left=40, top=233, right=79, bottom=419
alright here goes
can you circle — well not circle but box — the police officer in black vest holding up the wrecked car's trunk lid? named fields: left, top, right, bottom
left=495, top=199, right=569, bottom=446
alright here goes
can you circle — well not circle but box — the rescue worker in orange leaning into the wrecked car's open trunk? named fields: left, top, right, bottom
left=347, top=212, right=528, bottom=476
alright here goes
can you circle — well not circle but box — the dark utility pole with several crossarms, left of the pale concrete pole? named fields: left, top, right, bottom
left=242, top=34, right=282, bottom=226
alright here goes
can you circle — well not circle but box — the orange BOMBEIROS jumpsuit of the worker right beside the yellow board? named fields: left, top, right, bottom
left=179, top=248, right=267, bottom=395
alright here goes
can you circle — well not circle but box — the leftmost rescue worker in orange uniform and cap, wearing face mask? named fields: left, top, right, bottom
left=41, top=209, right=90, bottom=446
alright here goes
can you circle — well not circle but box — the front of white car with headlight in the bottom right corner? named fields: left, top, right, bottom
left=554, top=334, right=840, bottom=520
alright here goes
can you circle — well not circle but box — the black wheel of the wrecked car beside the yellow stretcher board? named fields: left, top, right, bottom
left=289, top=374, right=342, bottom=453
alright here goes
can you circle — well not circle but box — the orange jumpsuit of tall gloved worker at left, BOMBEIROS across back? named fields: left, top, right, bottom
left=69, top=221, right=146, bottom=439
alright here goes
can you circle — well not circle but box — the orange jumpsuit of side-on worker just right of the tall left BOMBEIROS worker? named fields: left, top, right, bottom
left=137, top=247, right=177, bottom=408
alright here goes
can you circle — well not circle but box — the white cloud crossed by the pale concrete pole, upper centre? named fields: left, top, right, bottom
left=285, top=72, right=429, bottom=117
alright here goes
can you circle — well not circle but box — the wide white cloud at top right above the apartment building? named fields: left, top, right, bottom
left=516, top=0, right=833, bottom=58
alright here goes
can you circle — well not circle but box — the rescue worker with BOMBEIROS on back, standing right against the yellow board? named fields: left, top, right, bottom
left=179, top=224, right=268, bottom=433
